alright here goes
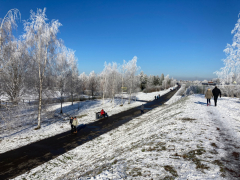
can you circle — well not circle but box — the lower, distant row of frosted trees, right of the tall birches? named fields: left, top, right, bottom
left=78, top=56, right=177, bottom=103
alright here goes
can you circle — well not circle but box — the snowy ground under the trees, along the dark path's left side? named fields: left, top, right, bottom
left=0, top=89, right=173, bottom=153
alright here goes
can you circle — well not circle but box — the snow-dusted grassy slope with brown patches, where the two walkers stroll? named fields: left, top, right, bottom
left=15, top=95, right=240, bottom=180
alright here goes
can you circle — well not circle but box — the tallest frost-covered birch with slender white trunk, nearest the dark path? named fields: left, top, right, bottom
left=23, top=8, right=61, bottom=128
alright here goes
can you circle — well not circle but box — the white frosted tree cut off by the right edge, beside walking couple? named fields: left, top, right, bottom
left=214, top=13, right=240, bottom=83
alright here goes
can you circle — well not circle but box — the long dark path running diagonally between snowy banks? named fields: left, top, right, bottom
left=0, top=88, right=179, bottom=179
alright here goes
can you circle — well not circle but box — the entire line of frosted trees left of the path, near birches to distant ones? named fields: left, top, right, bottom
left=0, top=9, right=176, bottom=128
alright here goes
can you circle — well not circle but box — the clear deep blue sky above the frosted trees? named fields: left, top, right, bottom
left=0, top=0, right=240, bottom=79
